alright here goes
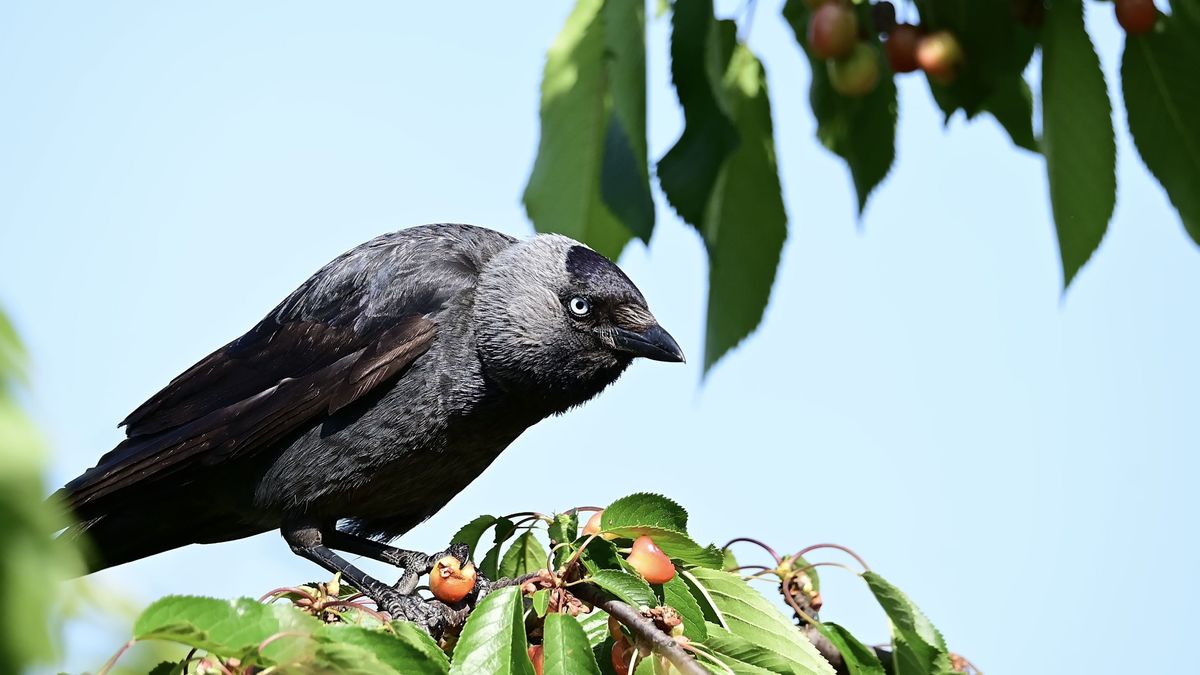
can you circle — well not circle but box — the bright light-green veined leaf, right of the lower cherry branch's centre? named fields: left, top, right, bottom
left=684, top=568, right=834, bottom=675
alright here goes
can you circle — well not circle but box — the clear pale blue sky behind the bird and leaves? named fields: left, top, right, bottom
left=0, top=1, right=1200, bottom=675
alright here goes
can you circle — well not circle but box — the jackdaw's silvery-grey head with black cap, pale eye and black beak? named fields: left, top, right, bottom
left=473, top=234, right=684, bottom=412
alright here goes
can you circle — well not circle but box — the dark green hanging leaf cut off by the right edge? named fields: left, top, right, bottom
left=1121, top=9, right=1200, bottom=244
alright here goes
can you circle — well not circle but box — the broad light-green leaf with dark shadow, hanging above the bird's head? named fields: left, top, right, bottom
left=524, top=0, right=654, bottom=258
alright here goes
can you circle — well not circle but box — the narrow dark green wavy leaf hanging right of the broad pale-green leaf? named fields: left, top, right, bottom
left=658, top=0, right=738, bottom=227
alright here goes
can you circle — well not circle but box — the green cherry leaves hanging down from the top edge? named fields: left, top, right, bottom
left=526, top=0, right=1200, bottom=370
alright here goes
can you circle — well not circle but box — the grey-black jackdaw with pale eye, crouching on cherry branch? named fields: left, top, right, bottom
left=54, top=223, right=684, bottom=627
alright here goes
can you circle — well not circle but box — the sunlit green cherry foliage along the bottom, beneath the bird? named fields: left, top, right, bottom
left=96, top=492, right=974, bottom=675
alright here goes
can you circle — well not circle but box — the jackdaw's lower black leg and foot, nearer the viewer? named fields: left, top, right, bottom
left=281, top=522, right=452, bottom=635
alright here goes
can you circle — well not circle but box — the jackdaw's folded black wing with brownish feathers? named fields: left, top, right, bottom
left=62, top=226, right=512, bottom=516
